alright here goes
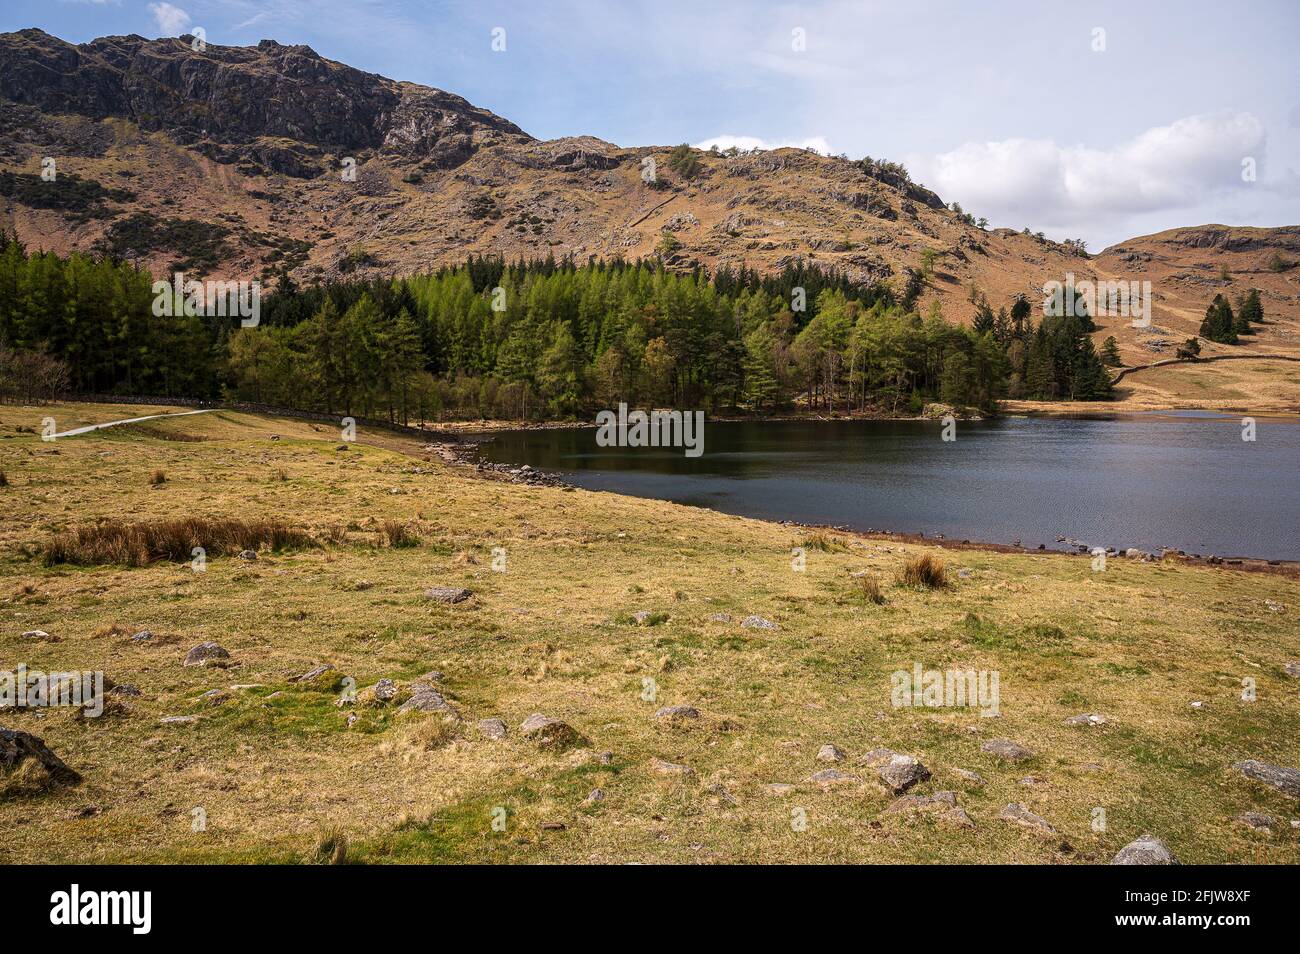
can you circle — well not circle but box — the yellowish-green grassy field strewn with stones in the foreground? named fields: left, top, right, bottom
left=0, top=404, right=1300, bottom=863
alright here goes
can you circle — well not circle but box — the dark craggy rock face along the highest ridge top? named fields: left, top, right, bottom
left=0, top=30, right=528, bottom=163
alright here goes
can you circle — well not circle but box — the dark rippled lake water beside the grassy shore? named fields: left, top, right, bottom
left=482, top=412, right=1300, bottom=560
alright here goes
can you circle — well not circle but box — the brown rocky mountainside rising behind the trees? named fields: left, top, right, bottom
left=0, top=30, right=1300, bottom=389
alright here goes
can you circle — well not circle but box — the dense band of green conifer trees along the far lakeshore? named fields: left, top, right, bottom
left=0, top=233, right=1109, bottom=422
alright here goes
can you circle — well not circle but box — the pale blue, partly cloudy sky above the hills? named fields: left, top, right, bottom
left=0, top=0, right=1300, bottom=251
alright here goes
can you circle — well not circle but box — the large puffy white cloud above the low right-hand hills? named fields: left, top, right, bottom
left=907, top=113, right=1266, bottom=239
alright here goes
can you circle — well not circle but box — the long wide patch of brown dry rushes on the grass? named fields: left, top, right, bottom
left=40, top=517, right=316, bottom=567
